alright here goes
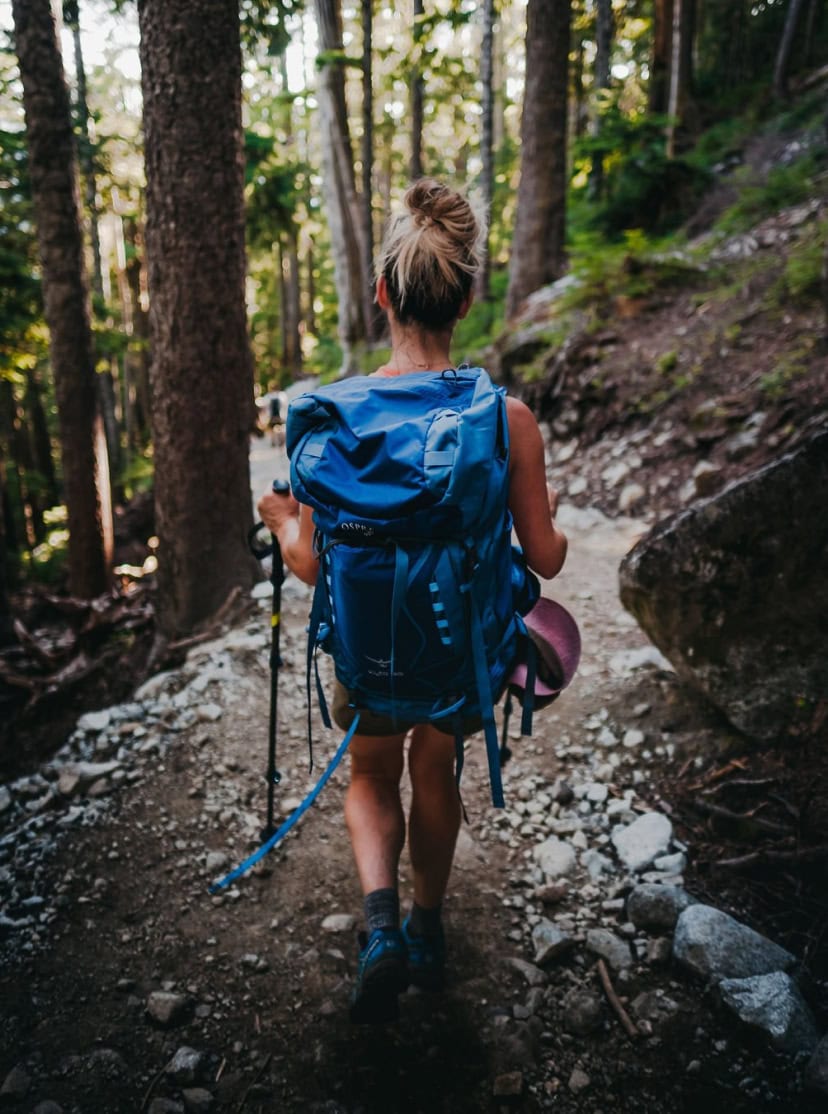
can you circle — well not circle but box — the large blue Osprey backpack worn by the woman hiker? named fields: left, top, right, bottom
left=286, top=368, right=538, bottom=808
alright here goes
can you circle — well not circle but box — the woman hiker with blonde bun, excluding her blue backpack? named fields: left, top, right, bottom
left=259, top=178, right=566, bottom=1022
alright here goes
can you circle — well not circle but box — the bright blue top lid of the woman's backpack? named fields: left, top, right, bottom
left=286, top=368, right=508, bottom=537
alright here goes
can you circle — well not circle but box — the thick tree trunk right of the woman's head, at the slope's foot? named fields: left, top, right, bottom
left=506, top=0, right=572, bottom=317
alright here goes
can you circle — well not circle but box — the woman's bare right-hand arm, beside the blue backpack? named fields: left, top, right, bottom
left=506, top=399, right=566, bottom=579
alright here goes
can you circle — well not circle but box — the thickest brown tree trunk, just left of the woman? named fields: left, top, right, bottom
left=138, top=0, right=255, bottom=637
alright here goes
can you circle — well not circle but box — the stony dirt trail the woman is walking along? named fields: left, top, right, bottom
left=0, top=442, right=805, bottom=1114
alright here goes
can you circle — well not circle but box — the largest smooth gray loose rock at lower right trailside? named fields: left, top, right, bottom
left=673, top=905, right=796, bottom=983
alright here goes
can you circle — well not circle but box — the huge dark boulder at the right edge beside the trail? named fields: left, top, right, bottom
left=621, top=430, right=828, bottom=740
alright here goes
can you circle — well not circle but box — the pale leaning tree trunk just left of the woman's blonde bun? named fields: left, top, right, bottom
left=314, top=0, right=367, bottom=375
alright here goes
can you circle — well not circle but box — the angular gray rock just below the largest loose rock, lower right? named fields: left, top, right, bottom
left=719, top=971, right=819, bottom=1056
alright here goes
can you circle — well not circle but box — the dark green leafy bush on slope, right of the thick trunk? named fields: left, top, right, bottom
left=573, top=99, right=709, bottom=237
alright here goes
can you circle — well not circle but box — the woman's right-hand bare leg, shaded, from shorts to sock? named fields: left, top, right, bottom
left=408, top=724, right=461, bottom=909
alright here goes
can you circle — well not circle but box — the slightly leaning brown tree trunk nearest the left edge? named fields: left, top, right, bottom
left=12, top=0, right=108, bottom=597
